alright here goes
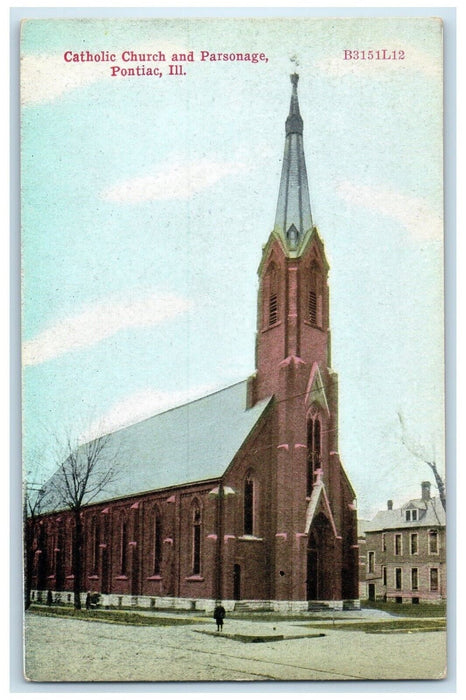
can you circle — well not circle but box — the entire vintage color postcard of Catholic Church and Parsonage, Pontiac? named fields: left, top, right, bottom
left=20, top=16, right=447, bottom=682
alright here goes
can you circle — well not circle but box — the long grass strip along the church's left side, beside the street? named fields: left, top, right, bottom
left=28, top=605, right=203, bottom=627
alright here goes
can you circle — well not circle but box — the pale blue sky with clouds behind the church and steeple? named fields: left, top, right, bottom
left=22, top=18, right=443, bottom=517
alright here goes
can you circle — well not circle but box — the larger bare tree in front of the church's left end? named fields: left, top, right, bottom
left=46, top=435, right=118, bottom=609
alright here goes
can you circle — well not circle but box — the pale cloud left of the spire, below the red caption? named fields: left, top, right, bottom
left=101, top=158, right=246, bottom=203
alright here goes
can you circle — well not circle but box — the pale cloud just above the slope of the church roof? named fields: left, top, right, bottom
left=79, top=385, right=219, bottom=443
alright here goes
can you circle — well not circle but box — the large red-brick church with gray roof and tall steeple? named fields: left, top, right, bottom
left=28, top=74, right=358, bottom=611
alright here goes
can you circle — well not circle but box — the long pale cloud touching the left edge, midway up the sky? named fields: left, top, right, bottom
left=23, top=294, right=191, bottom=365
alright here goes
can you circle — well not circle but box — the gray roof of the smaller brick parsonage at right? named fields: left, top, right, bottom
left=365, top=497, right=445, bottom=532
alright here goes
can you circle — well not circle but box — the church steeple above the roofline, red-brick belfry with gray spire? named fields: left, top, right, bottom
left=251, top=74, right=330, bottom=405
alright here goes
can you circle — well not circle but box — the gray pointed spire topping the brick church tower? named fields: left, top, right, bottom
left=274, top=73, right=312, bottom=250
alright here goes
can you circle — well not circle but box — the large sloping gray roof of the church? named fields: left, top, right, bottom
left=85, top=381, right=271, bottom=501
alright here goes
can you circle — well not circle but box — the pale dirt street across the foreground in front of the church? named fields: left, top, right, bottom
left=25, top=614, right=445, bottom=681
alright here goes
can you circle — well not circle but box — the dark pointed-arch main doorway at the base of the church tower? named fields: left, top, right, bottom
left=307, top=513, right=335, bottom=600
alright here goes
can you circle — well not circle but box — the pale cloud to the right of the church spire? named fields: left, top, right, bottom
left=337, top=182, right=443, bottom=241
